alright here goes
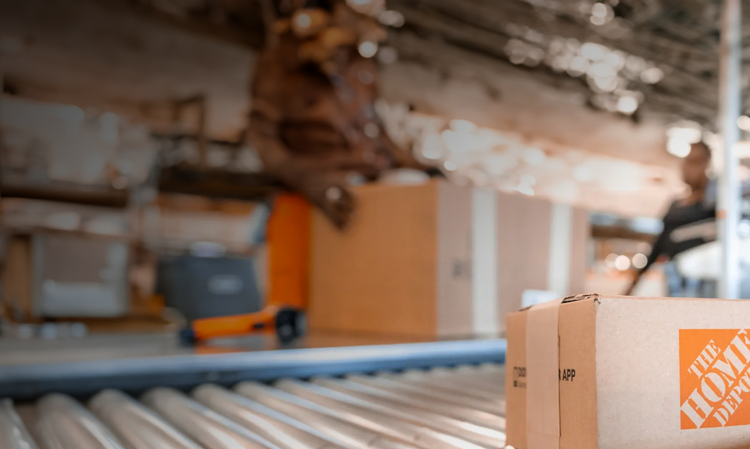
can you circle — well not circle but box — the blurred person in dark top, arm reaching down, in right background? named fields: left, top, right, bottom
left=625, top=142, right=717, bottom=295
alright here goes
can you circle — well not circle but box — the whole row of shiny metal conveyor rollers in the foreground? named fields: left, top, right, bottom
left=0, top=363, right=505, bottom=449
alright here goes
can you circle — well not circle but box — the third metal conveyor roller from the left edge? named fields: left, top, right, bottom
left=89, top=390, right=202, bottom=449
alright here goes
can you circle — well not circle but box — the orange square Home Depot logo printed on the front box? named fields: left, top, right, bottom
left=680, top=329, right=750, bottom=430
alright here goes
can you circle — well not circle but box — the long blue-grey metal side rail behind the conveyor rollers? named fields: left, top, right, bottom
left=0, top=339, right=506, bottom=401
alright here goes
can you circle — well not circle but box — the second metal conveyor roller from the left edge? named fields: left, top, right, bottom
left=36, top=394, right=125, bottom=449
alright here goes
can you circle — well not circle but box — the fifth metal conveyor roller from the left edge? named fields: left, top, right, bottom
left=193, top=384, right=350, bottom=449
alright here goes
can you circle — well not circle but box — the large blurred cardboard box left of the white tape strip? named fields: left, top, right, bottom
left=308, top=181, right=472, bottom=336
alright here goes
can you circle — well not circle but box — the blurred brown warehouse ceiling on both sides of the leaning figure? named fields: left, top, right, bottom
left=0, top=0, right=750, bottom=213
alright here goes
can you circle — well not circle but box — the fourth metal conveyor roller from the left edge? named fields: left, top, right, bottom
left=141, top=388, right=281, bottom=449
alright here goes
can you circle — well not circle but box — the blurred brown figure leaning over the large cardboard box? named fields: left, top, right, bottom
left=247, top=0, right=434, bottom=228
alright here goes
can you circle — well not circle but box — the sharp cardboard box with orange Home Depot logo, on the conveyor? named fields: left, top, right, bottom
left=506, top=295, right=750, bottom=449
